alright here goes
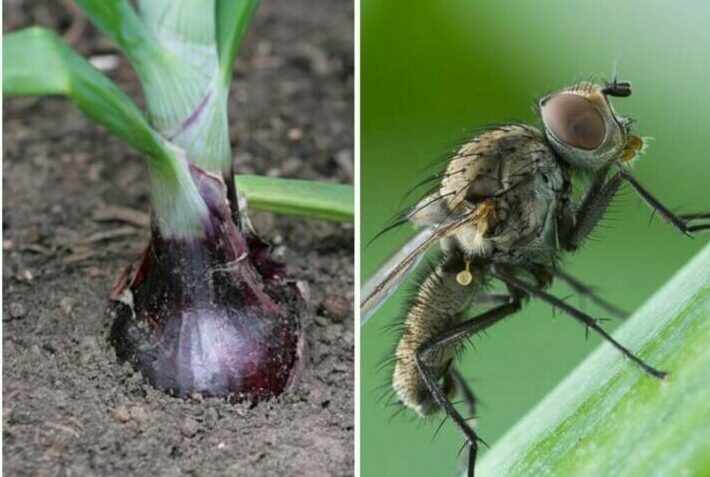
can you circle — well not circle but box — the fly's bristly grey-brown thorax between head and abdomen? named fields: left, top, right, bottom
left=438, top=125, right=568, bottom=263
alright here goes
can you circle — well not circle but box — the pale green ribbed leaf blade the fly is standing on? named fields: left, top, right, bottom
left=476, top=245, right=710, bottom=477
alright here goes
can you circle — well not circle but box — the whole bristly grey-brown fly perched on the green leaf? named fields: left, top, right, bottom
left=361, top=79, right=710, bottom=477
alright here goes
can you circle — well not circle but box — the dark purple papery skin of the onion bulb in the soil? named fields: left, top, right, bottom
left=109, top=166, right=305, bottom=401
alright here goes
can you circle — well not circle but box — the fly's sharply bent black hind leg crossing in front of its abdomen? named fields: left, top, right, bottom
left=416, top=300, right=521, bottom=477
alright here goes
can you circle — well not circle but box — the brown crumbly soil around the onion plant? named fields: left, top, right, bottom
left=2, top=0, right=354, bottom=476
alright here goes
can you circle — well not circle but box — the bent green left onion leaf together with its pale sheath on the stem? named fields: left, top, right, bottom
left=3, top=27, right=206, bottom=238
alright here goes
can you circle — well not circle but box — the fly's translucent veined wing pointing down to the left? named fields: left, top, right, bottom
left=360, top=216, right=471, bottom=326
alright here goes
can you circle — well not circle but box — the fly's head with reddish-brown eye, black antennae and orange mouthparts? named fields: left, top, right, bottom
left=538, top=79, right=643, bottom=170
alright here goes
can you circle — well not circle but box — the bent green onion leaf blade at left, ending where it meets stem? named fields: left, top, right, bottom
left=3, top=27, right=172, bottom=169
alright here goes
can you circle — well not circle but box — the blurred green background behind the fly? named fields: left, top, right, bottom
left=360, top=0, right=710, bottom=477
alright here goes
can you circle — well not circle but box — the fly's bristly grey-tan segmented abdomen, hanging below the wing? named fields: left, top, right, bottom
left=392, top=255, right=484, bottom=416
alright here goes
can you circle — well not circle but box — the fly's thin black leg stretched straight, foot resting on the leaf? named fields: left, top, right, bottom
left=494, top=269, right=668, bottom=379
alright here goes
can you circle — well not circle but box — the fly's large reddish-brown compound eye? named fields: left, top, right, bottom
left=542, top=94, right=606, bottom=151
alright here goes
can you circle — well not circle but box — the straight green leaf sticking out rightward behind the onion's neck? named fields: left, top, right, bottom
left=235, top=175, right=354, bottom=222
